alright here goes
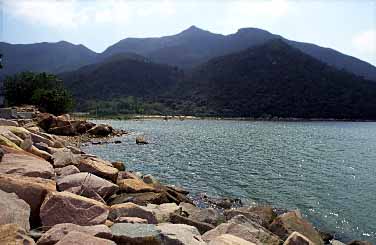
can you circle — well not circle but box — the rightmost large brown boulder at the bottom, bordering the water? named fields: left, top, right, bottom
left=269, top=212, right=324, bottom=245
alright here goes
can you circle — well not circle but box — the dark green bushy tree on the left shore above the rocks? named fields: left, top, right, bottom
left=4, top=72, right=73, bottom=115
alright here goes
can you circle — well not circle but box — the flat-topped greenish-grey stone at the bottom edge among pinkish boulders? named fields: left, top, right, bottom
left=111, top=223, right=163, bottom=245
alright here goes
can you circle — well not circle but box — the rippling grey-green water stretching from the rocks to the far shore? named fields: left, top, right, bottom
left=85, top=120, right=376, bottom=243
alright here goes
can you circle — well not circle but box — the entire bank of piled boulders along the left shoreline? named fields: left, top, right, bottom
left=0, top=114, right=370, bottom=245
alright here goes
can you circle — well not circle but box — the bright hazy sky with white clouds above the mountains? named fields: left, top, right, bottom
left=0, top=0, right=376, bottom=65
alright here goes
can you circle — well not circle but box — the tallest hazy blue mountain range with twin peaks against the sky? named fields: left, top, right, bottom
left=101, top=26, right=376, bottom=81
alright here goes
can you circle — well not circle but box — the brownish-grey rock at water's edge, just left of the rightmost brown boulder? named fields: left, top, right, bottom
left=223, top=206, right=277, bottom=227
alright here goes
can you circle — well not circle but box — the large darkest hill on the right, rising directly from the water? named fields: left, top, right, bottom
left=175, top=39, right=376, bottom=119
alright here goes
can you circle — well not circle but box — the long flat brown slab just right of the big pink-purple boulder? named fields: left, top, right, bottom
left=109, top=192, right=169, bottom=206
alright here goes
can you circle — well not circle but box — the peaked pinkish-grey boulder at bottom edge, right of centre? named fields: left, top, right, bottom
left=202, top=215, right=281, bottom=245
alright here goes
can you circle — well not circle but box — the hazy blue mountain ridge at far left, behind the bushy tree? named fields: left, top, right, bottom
left=0, top=41, right=97, bottom=77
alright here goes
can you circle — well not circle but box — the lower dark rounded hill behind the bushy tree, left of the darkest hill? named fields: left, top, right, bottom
left=58, top=53, right=182, bottom=100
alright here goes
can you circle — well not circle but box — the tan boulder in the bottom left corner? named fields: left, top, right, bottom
left=0, top=224, right=35, bottom=245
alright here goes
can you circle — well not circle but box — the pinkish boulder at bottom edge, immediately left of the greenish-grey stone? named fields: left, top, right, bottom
left=37, top=223, right=112, bottom=245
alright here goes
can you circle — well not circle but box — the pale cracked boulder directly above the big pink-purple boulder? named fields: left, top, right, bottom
left=57, top=172, right=119, bottom=199
